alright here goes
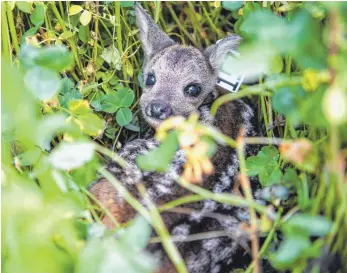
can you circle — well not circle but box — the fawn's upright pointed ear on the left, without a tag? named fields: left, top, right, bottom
left=135, top=3, right=175, bottom=59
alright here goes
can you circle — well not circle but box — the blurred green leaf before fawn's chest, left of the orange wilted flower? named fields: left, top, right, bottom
left=136, top=132, right=178, bottom=172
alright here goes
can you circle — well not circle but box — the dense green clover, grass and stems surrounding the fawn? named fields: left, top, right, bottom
left=1, top=1, right=347, bottom=273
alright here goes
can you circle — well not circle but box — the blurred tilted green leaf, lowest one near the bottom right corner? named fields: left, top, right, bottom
left=270, top=234, right=310, bottom=269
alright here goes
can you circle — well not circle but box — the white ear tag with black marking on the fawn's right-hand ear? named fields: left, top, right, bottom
left=217, top=40, right=244, bottom=93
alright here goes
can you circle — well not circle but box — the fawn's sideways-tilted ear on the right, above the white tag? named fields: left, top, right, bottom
left=204, top=35, right=242, bottom=70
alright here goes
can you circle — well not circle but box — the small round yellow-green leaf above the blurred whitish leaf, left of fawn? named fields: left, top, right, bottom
left=75, top=113, right=105, bottom=137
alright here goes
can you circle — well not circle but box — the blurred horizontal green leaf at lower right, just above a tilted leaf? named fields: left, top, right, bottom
left=283, top=213, right=332, bottom=236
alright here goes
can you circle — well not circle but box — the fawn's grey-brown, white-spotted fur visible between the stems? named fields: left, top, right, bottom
left=90, top=4, right=264, bottom=273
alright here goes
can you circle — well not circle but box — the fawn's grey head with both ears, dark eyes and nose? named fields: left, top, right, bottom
left=135, top=3, right=241, bottom=127
